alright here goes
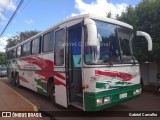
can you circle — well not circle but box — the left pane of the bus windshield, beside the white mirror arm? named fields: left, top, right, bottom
left=85, top=21, right=120, bottom=64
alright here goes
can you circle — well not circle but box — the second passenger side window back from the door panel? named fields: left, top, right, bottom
left=32, top=38, right=40, bottom=54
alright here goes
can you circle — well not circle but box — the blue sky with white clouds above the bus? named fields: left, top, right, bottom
left=0, top=0, right=141, bottom=52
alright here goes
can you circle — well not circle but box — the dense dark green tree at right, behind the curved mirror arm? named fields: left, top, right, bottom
left=118, top=0, right=160, bottom=62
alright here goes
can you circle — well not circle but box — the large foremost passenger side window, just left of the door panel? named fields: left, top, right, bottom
left=43, top=32, right=54, bottom=52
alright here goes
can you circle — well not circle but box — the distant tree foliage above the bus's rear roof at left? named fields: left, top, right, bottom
left=6, top=30, right=39, bottom=48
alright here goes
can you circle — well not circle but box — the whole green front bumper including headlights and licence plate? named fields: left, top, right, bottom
left=84, top=84, right=141, bottom=111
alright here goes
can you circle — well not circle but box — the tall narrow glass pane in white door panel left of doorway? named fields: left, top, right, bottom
left=54, top=29, right=65, bottom=66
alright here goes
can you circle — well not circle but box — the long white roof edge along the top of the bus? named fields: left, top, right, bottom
left=6, top=14, right=133, bottom=51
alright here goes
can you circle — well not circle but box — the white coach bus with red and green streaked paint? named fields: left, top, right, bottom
left=6, top=14, right=152, bottom=111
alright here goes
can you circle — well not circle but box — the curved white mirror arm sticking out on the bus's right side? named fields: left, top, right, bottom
left=136, top=31, right=152, bottom=51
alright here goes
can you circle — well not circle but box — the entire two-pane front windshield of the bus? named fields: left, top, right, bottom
left=85, top=20, right=135, bottom=64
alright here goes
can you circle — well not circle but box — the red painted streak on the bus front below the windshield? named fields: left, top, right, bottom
left=95, top=70, right=134, bottom=81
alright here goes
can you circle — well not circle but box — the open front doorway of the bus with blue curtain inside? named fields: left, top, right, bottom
left=68, top=24, right=83, bottom=109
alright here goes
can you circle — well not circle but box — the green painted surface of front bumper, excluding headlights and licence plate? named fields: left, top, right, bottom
left=84, top=84, right=141, bottom=111
